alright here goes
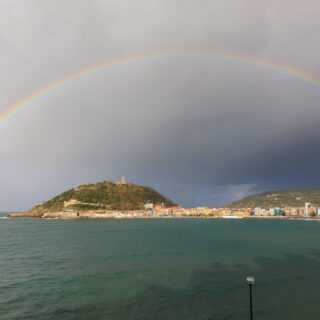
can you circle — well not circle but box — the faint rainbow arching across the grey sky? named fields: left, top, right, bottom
left=0, top=50, right=320, bottom=122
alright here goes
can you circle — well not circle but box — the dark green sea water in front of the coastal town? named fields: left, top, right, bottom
left=0, top=219, right=320, bottom=320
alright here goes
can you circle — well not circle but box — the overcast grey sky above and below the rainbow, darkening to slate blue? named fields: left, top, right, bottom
left=0, top=0, right=320, bottom=210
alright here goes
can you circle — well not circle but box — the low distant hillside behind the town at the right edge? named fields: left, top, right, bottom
left=227, top=188, right=320, bottom=208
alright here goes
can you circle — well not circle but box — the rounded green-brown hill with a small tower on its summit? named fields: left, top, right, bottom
left=31, top=181, right=174, bottom=213
